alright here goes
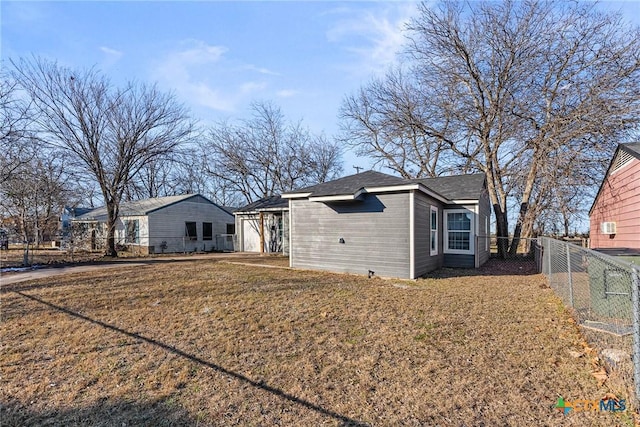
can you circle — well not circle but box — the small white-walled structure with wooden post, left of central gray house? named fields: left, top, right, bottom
left=233, top=196, right=289, bottom=255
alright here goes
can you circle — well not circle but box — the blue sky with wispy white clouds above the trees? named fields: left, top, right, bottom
left=0, top=0, right=640, bottom=174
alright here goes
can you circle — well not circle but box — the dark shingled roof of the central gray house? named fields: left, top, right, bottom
left=283, top=171, right=485, bottom=201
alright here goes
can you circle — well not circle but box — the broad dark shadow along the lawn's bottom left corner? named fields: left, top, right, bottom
left=0, top=397, right=198, bottom=427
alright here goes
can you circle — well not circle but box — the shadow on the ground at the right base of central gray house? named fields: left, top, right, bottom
left=423, top=258, right=539, bottom=279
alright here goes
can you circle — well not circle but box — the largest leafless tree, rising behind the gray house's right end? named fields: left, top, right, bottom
left=345, top=0, right=640, bottom=255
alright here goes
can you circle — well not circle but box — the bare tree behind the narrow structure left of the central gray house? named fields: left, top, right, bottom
left=203, top=102, right=341, bottom=203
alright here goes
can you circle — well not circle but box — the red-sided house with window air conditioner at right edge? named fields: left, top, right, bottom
left=589, top=143, right=640, bottom=249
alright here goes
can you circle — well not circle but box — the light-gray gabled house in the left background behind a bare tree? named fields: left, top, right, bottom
left=73, top=194, right=234, bottom=254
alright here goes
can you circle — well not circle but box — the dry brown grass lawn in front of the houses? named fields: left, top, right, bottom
left=0, top=259, right=633, bottom=426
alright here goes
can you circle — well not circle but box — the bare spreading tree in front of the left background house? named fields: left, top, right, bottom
left=12, top=59, right=193, bottom=256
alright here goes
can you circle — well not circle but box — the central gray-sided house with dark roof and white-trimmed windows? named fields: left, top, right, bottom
left=282, top=171, right=491, bottom=279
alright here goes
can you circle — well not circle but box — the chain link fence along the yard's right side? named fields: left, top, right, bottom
left=537, top=237, right=640, bottom=405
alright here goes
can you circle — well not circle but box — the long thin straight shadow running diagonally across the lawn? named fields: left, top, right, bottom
left=12, top=291, right=369, bottom=426
